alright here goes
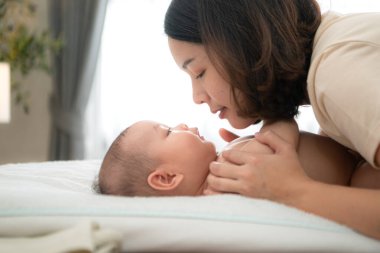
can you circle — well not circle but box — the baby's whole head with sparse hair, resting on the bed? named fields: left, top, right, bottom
left=98, top=121, right=216, bottom=196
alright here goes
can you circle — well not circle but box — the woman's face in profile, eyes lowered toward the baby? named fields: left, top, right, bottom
left=169, top=38, right=257, bottom=129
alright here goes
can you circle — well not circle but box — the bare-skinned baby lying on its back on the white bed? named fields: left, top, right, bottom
left=96, top=121, right=378, bottom=196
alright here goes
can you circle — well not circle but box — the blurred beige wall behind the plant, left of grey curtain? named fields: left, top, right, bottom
left=0, top=0, right=52, bottom=164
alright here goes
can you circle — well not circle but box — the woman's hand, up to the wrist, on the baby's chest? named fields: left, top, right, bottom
left=206, top=131, right=310, bottom=202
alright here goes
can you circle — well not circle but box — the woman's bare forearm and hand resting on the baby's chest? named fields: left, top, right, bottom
left=208, top=131, right=380, bottom=239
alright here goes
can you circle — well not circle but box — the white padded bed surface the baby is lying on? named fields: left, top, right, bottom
left=0, top=160, right=380, bottom=253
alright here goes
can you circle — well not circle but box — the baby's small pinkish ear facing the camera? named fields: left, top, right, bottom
left=147, top=168, right=184, bottom=191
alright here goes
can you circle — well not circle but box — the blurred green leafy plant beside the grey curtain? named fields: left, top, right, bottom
left=0, top=0, right=63, bottom=113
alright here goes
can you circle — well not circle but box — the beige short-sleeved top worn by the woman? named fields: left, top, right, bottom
left=308, top=12, right=380, bottom=166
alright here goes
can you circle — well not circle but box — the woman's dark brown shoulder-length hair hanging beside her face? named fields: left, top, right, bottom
left=165, top=0, right=321, bottom=119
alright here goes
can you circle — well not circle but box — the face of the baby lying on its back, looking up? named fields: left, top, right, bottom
left=127, top=121, right=217, bottom=195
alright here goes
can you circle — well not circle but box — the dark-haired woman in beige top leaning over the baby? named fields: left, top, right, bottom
left=165, top=0, right=380, bottom=239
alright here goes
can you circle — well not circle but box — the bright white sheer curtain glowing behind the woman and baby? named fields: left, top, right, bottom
left=87, top=0, right=380, bottom=158
